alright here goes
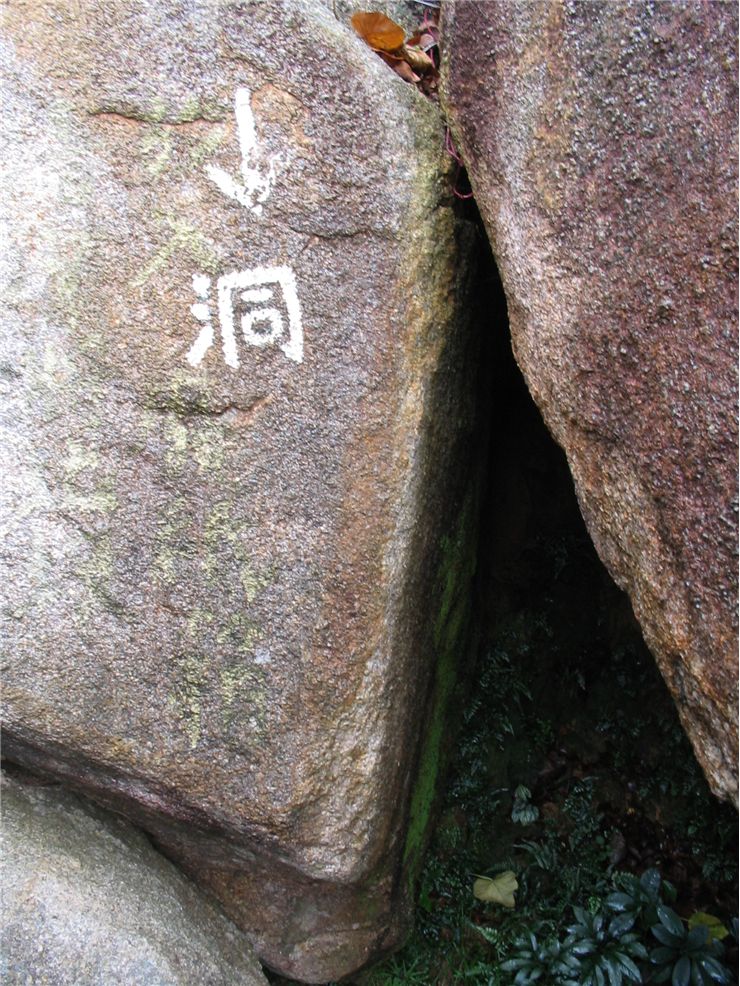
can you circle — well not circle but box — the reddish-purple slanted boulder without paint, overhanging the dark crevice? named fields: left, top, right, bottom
left=443, top=0, right=737, bottom=799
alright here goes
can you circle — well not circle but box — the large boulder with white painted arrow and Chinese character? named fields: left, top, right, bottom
left=1, top=0, right=482, bottom=982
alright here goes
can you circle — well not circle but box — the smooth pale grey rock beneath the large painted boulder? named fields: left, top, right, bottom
left=0, top=778, right=267, bottom=986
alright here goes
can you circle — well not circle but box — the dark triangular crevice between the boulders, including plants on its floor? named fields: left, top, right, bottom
left=356, top=221, right=737, bottom=986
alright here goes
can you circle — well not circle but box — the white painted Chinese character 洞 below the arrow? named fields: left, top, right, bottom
left=187, top=267, right=303, bottom=369
